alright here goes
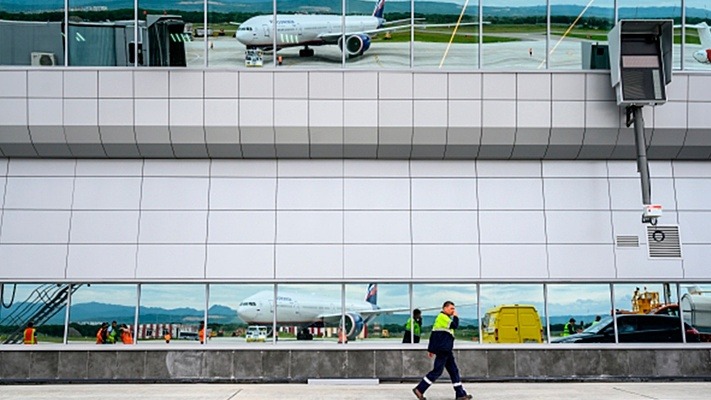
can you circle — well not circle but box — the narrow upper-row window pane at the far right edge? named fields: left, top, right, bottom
left=675, top=0, right=711, bottom=70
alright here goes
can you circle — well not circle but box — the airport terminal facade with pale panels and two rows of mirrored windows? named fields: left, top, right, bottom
left=0, top=0, right=711, bottom=383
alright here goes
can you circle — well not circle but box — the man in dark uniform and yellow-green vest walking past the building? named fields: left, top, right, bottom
left=412, top=301, right=472, bottom=400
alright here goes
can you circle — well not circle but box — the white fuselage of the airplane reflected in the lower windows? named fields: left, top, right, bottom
left=237, top=291, right=374, bottom=326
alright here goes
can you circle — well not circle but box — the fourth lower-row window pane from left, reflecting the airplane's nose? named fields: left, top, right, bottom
left=207, top=284, right=274, bottom=344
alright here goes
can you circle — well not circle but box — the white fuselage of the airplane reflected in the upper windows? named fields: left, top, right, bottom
left=236, top=14, right=382, bottom=48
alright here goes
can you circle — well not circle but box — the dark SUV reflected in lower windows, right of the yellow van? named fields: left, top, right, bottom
left=551, top=314, right=699, bottom=343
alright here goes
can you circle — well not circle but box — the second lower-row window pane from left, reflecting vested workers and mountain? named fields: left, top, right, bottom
left=67, top=283, right=138, bottom=344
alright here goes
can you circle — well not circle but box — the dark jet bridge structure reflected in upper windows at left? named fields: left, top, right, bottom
left=0, top=15, right=190, bottom=67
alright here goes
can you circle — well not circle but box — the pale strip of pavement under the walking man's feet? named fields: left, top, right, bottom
left=0, top=381, right=711, bottom=400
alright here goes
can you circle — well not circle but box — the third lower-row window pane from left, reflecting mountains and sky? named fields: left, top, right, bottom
left=138, top=283, right=206, bottom=344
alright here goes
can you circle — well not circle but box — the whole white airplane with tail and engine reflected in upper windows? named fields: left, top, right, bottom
left=235, top=0, right=392, bottom=57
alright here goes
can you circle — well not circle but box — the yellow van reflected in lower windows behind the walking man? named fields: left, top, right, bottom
left=482, top=304, right=543, bottom=343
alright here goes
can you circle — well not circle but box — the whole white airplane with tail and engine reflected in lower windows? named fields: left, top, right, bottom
left=237, top=283, right=410, bottom=340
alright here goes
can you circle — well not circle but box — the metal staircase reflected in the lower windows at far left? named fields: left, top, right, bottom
left=0, top=283, right=82, bottom=344
